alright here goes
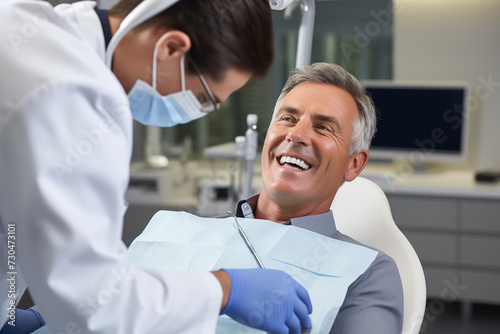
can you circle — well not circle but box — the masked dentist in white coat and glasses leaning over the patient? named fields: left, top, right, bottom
left=0, top=0, right=312, bottom=334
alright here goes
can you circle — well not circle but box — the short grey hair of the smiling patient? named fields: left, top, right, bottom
left=271, top=63, right=377, bottom=156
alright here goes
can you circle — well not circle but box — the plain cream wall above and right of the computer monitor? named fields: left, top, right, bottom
left=394, top=0, right=500, bottom=170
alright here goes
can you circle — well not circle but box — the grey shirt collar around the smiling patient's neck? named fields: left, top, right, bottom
left=236, top=195, right=338, bottom=237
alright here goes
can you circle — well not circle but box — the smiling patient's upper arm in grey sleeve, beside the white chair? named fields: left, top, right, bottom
left=330, top=253, right=403, bottom=334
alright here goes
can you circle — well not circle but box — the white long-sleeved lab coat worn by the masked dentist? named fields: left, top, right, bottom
left=0, top=0, right=222, bottom=334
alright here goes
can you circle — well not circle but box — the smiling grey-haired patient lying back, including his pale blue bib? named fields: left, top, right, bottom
left=128, top=63, right=403, bottom=334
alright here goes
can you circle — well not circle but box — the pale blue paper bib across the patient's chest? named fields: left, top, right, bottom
left=128, top=211, right=377, bottom=334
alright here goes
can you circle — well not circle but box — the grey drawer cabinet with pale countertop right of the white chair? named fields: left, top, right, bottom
left=381, top=172, right=500, bottom=304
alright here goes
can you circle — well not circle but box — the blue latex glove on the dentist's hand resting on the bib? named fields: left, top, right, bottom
left=221, top=268, right=312, bottom=334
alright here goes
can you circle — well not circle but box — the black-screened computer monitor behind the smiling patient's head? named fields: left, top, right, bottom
left=363, top=81, right=469, bottom=167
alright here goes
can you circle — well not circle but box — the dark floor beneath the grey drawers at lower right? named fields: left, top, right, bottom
left=420, top=301, right=500, bottom=334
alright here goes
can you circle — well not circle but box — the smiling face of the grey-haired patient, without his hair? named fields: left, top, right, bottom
left=262, top=83, right=364, bottom=208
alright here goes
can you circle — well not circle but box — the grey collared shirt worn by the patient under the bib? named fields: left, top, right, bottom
left=236, top=195, right=403, bottom=334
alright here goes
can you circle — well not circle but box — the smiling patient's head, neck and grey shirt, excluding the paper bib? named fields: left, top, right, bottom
left=232, top=63, right=403, bottom=334
